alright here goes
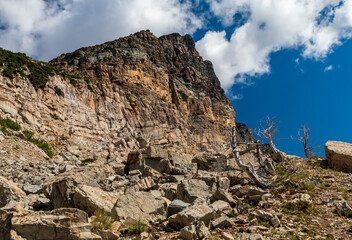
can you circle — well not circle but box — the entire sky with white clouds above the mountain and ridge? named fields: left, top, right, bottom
left=0, top=0, right=352, bottom=155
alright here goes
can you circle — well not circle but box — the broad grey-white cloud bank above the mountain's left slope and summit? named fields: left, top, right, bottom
left=0, top=0, right=202, bottom=60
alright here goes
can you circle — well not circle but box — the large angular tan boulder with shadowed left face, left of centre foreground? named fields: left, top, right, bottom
left=43, top=165, right=120, bottom=215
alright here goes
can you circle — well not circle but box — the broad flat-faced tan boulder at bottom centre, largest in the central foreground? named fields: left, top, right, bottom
left=111, top=192, right=167, bottom=224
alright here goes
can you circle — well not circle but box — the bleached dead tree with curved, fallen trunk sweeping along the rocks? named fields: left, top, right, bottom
left=231, top=128, right=295, bottom=188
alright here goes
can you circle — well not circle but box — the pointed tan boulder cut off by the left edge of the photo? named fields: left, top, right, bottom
left=0, top=176, right=26, bottom=208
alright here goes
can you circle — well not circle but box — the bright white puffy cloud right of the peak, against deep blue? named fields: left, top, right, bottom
left=196, top=0, right=352, bottom=89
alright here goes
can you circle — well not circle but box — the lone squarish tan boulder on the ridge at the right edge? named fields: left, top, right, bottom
left=325, top=141, right=352, bottom=172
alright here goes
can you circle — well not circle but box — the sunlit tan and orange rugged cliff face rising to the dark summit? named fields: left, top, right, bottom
left=0, top=31, right=235, bottom=158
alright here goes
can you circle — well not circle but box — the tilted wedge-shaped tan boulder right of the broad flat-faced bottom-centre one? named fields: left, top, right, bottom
left=168, top=202, right=216, bottom=229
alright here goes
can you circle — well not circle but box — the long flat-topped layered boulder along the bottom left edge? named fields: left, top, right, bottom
left=12, top=208, right=101, bottom=240
